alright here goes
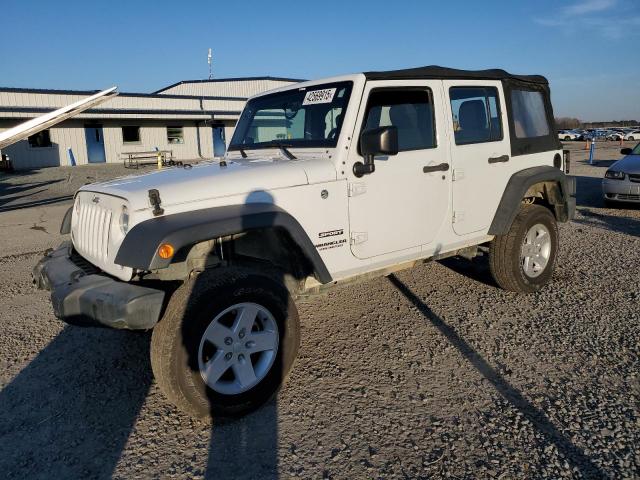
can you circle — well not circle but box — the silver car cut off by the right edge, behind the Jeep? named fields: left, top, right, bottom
left=602, top=143, right=640, bottom=203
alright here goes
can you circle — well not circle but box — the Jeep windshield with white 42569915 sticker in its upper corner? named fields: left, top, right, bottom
left=229, top=82, right=353, bottom=150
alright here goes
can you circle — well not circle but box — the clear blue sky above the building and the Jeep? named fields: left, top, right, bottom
left=0, top=0, right=640, bottom=120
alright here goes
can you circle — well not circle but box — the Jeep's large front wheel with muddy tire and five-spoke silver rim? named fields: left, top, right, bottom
left=151, top=267, right=300, bottom=417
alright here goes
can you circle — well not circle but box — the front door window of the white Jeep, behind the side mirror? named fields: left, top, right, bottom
left=364, top=89, right=436, bottom=152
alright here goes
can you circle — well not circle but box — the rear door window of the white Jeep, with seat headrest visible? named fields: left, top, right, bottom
left=449, top=87, right=502, bottom=145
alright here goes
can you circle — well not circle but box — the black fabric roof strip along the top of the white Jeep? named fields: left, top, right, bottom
left=364, top=65, right=549, bottom=85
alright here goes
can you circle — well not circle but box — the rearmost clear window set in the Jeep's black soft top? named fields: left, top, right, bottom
left=511, top=89, right=550, bottom=138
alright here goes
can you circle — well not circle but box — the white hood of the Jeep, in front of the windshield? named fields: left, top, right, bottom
left=80, top=158, right=336, bottom=210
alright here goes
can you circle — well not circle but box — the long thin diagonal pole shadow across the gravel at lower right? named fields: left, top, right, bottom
left=387, top=275, right=607, bottom=478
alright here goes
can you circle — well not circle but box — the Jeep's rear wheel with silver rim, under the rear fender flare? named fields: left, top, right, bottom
left=489, top=205, right=558, bottom=293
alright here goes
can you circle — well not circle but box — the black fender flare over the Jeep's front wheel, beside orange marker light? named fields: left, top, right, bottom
left=115, top=203, right=332, bottom=283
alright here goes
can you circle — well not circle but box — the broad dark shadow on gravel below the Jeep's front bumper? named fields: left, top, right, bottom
left=0, top=326, right=151, bottom=479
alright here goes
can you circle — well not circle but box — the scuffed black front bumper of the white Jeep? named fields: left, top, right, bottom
left=33, top=242, right=165, bottom=330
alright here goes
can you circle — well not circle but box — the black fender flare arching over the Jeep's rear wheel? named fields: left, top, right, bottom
left=488, top=165, right=576, bottom=235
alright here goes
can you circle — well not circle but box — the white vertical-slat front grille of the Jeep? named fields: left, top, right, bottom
left=73, top=200, right=111, bottom=261
